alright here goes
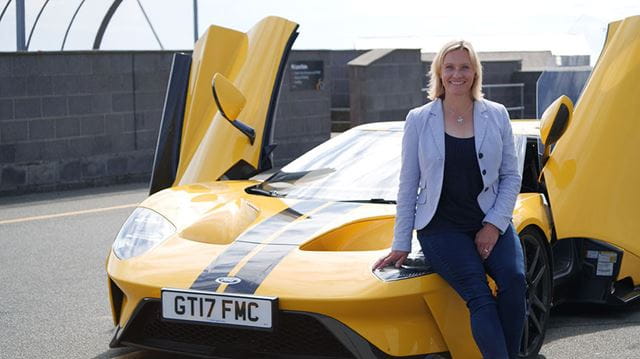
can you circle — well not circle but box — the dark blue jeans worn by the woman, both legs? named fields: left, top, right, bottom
left=418, top=225, right=526, bottom=359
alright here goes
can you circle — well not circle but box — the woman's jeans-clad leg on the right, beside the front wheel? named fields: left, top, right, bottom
left=484, top=225, right=527, bottom=358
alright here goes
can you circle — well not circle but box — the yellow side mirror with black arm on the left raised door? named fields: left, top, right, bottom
left=211, top=73, right=256, bottom=145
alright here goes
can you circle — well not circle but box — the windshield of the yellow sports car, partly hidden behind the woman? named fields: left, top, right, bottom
left=257, top=126, right=526, bottom=203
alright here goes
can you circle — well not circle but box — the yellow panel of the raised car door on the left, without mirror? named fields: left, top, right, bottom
left=174, top=17, right=298, bottom=185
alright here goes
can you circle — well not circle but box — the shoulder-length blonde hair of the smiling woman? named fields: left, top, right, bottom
left=427, top=40, right=484, bottom=100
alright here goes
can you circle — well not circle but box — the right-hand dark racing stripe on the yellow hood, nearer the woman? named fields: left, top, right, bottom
left=225, top=202, right=362, bottom=294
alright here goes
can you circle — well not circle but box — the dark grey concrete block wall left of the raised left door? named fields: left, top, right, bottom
left=0, top=52, right=171, bottom=194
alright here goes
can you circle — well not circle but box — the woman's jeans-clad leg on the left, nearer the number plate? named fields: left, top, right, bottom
left=418, top=231, right=508, bottom=359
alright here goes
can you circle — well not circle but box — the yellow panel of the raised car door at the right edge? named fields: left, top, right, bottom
left=544, top=16, right=640, bottom=285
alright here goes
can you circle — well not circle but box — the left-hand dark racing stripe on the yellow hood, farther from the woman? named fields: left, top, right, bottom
left=191, top=201, right=324, bottom=291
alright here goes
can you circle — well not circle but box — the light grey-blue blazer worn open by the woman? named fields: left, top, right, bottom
left=392, top=99, right=522, bottom=252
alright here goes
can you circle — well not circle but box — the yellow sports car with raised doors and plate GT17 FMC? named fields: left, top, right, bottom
left=107, top=17, right=640, bottom=359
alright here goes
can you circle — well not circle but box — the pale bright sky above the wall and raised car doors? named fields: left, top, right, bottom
left=0, top=0, right=640, bottom=63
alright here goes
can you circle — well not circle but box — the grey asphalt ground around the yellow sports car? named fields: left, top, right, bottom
left=0, top=185, right=640, bottom=359
